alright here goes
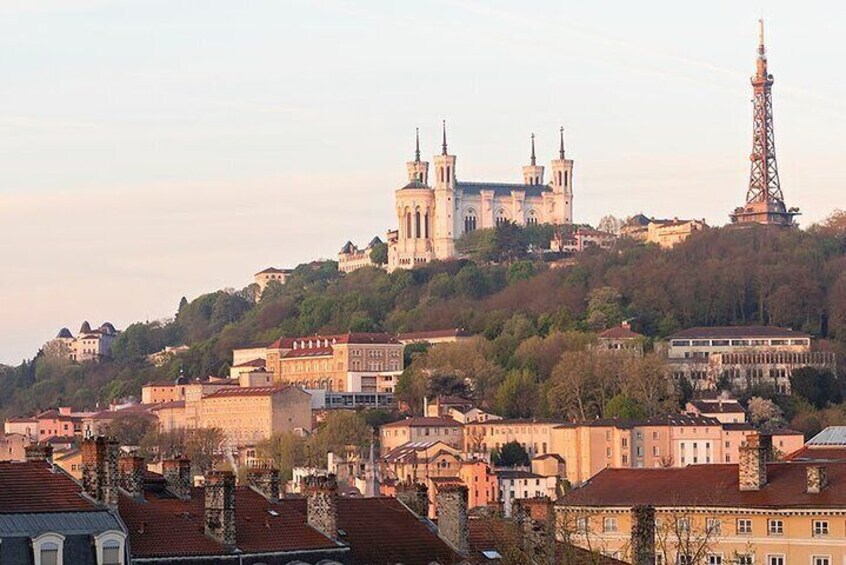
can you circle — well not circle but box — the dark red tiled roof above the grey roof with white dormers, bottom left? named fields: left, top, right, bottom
left=0, top=461, right=99, bottom=514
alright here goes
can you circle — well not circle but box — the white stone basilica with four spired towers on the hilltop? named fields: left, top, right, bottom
left=388, top=125, right=573, bottom=271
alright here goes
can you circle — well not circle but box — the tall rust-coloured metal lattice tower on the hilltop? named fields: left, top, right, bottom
left=731, top=20, right=799, bottom=226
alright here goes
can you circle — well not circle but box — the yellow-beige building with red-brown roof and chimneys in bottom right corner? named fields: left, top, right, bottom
left=556, top=435, right=846, bottom=565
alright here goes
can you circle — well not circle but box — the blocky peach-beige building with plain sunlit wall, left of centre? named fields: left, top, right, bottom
left=201, top=386, right=311, bottom=447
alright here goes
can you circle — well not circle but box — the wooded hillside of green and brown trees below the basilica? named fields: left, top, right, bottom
left=0, top=218, right=846, bottom=426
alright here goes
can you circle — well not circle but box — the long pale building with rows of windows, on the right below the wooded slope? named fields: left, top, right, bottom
left=667, top=326, right=837, bottom=394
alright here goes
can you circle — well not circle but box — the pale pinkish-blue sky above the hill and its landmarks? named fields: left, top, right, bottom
left=0, top=0, right=846, bottom=364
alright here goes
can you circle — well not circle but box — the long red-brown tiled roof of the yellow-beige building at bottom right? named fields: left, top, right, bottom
left=562, top=462, right=846, bottom=508
